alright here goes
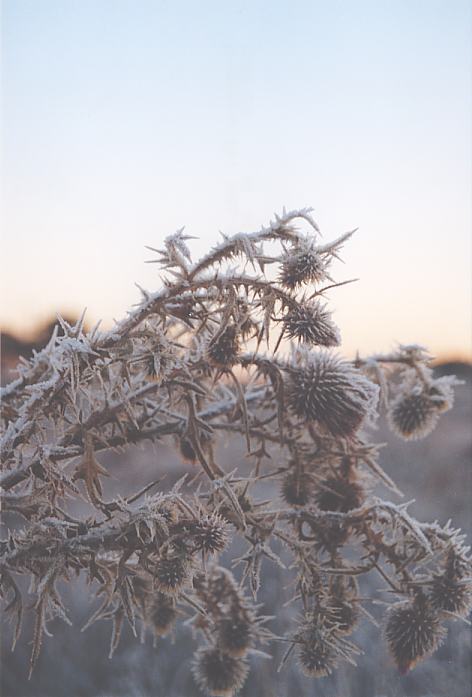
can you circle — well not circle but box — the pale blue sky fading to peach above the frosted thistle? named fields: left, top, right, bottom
left=0, top=0, right=472, bottom=359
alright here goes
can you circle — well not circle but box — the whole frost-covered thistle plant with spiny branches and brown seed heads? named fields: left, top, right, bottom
left=0, top=205, right=472, bottom=696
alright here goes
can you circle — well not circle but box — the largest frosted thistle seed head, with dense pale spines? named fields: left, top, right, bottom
left=287, top=348, right=378, bottom=436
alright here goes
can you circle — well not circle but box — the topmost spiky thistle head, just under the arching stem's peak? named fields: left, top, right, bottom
left=279, top=240, right=329, bottom=289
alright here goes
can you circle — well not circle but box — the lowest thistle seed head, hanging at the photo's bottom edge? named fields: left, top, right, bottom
left=192, top=646, right=249, bottom=697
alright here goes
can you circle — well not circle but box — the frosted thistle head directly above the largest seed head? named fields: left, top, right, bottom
left=283, top=302, right=341, bottom=347
